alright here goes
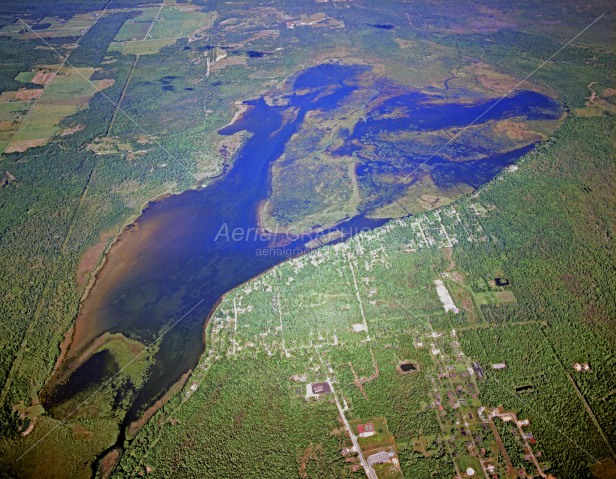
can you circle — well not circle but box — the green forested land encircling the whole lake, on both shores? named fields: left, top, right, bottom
left=0, top=0, right=616, bottom=478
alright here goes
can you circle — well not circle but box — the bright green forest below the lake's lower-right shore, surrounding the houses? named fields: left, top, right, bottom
left=116, top=117, right=616, bottom=478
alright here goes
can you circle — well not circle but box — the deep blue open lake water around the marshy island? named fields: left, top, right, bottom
left=48, top=65, right=562, bottom=421
